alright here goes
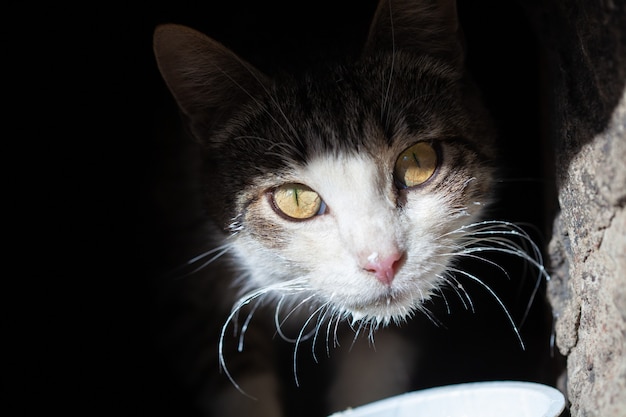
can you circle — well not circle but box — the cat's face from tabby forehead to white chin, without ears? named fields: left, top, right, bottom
left=222, top=61, right=492, bottom=322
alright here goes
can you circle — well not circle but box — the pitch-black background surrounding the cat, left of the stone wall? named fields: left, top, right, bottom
left=3, top=0, right=554, bottom=416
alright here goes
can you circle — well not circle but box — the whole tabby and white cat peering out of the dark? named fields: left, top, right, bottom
left=154, top=0, right=545, bottom=417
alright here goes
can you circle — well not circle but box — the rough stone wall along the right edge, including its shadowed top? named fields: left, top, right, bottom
left=532, top=0, right=626, bottom=417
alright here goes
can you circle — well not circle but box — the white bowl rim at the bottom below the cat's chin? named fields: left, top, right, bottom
left=329, top=381, right=565, bottom=417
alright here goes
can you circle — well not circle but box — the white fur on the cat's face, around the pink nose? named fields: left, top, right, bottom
left=229, top=154, right=482, bottom=323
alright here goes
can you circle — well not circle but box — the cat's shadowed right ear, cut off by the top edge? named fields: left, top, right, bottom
left=364, top=0, right=464, bottom=64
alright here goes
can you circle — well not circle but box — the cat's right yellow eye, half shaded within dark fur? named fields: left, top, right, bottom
left=394, top=142, right=437, bottom=187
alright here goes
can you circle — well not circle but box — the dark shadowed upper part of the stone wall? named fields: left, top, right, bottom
left=521, top=0, right=626, bottom=181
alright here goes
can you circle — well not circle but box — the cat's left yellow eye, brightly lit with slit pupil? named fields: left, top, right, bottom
left=272, top=184, right=325, bottom=220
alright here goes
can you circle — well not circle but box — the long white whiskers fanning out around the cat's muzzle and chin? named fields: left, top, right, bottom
left=216, top=216, right=549, bottom=396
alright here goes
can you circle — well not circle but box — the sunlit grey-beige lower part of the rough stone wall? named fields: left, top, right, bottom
left=548, top=96, right=626, bottom=417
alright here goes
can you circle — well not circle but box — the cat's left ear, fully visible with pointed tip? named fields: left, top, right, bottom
left=153, top=24, right=268, bottom=142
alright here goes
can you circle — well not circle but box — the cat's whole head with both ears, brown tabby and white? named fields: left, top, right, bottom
left=155, top=0, right=493, bottom=323
